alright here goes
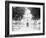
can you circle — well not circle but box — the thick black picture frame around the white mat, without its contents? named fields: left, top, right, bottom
left=5, top=1, right=45, bottom=37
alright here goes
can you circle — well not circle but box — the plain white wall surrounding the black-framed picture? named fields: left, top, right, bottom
left=0, top=0, right=46, bottom=38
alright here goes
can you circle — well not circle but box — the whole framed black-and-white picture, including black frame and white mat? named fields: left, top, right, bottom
left=5, top=1, right=45, bottom=37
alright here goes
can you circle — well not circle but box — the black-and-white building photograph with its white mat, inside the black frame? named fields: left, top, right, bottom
left=5, top=3, right=44, bottom=35
